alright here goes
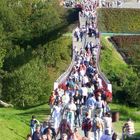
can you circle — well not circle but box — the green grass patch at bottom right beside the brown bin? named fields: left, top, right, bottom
left=110, top=104, right=140, bottom=136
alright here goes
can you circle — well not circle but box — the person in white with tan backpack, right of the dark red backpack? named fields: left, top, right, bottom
left=92, top=114, right=103, bottom=140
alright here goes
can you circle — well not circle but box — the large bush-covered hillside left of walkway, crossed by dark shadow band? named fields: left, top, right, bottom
left=0, top=0, right=78, bottom=108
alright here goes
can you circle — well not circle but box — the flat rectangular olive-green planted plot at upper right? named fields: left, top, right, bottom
left=98, top=8, right=140, bottom=33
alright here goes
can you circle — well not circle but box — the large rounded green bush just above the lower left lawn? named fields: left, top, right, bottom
left=2, top=58, right=51, bottom=107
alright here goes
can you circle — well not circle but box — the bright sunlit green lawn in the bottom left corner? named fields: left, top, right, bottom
left=0, top=104, right=50, bottom=140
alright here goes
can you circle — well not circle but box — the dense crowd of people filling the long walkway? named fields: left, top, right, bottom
left=28, top=0, right=135, bottom=140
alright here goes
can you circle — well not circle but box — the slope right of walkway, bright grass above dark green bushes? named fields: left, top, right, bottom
left=100, top=36, right=140, bottom=106
